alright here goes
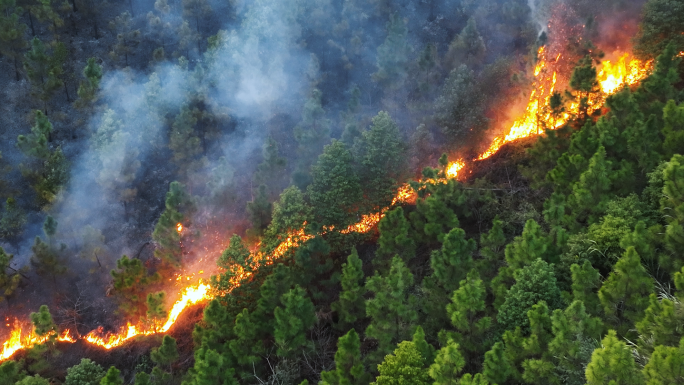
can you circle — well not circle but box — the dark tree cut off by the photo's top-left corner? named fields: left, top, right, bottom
left=0, top=0, right=28, bottom=81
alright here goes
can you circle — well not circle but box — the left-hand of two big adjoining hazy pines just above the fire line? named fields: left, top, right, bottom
left=307, top=140, right=362, bottom=228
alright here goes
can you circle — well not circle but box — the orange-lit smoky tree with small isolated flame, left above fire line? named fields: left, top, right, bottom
left=152, top=182, right=197, bottom=267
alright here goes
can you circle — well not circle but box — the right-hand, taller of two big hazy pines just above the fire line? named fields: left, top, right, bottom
left=354, top=111, right=408, bottom=212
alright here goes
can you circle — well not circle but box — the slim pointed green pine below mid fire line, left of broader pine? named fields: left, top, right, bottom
left=331, top=247, right=366, bottom=329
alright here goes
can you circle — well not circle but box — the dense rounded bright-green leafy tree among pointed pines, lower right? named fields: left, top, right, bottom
left=492, top=259, right=563, bottom=330
